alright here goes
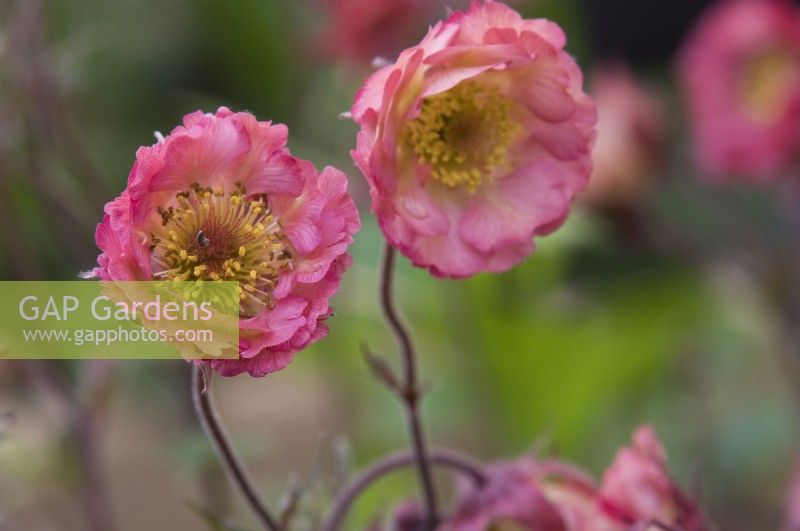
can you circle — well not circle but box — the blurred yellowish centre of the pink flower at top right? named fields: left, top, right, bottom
left=741, top=52, right=800, bottom=123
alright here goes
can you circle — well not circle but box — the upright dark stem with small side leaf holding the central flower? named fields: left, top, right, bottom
left=380, top=244, right=439, bottom=529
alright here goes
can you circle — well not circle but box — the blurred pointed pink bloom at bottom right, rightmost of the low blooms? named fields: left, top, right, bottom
left=599, top=426, right=710, bottom=531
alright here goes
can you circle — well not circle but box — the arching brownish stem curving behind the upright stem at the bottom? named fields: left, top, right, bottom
left=322, top=450, right=486, bottom=531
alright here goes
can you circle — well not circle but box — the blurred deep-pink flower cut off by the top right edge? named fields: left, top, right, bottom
left=679, top=0, right=800, bottom=181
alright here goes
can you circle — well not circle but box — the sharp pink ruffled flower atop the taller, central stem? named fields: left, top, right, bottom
left=351, top=0, right=596, bottom=278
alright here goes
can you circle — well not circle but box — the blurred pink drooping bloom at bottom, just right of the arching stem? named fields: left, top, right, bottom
left=439, top=458, right=596, bottom=531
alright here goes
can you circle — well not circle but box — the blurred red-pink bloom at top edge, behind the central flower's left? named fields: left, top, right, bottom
left=319, top=0, right=444, bottom=64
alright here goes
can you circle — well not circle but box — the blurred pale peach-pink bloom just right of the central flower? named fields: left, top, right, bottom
left=581, top=64, right=664, bottom=207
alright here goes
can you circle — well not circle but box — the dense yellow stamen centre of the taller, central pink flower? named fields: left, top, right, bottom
left=405, top=81, right=520, bottom=193
